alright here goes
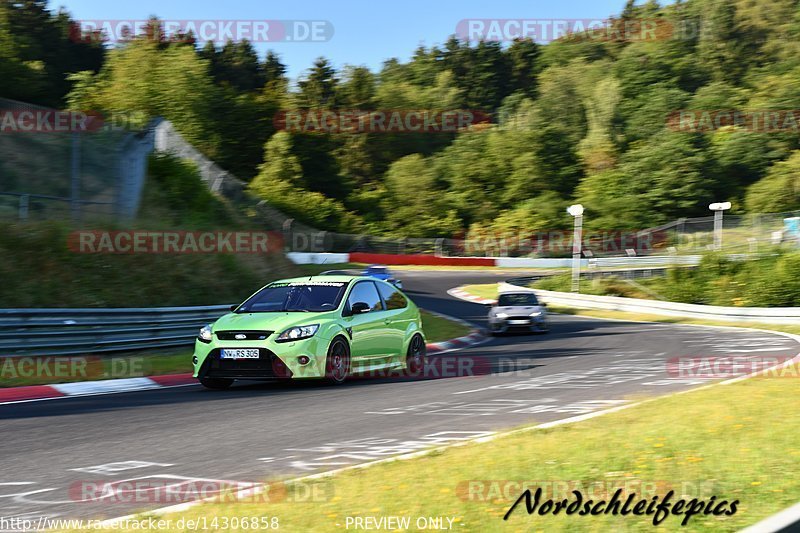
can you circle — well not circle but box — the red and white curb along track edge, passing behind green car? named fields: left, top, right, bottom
left=0, top=313, right=486, bottom=405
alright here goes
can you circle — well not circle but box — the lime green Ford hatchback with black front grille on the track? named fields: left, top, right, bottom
left=192, top=276, right=425, bottom=389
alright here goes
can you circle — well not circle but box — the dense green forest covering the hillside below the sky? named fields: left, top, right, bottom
left=0, top=0, right=800, bottom=236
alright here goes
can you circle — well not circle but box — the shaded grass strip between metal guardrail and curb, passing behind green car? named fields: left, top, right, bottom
left=0, top=311, right=470, bottom=388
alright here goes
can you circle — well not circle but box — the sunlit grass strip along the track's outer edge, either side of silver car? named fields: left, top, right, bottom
left=462, top=283, right=800, bottom=335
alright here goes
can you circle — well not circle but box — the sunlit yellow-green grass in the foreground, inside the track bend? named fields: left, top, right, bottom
left=67, top=362, right=800, bottom=531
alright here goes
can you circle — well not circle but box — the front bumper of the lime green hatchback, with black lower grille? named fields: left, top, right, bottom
left=192, top=332, right=330, bottom=380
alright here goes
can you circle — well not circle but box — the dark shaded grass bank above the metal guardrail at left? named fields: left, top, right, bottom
left=0, top=222, right=297, bottom=308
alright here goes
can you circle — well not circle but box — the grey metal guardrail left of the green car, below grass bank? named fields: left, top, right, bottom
left=0, top=305, right=230, bottom=357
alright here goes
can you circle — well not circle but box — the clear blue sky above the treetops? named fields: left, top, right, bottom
left=50, top=0, right=660, bottom=79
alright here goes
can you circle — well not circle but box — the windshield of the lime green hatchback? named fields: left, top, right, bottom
left=236, top=281, right=347, bottom=313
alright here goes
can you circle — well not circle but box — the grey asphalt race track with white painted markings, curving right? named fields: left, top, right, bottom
left=0, top=271, right=800, bottom=518
